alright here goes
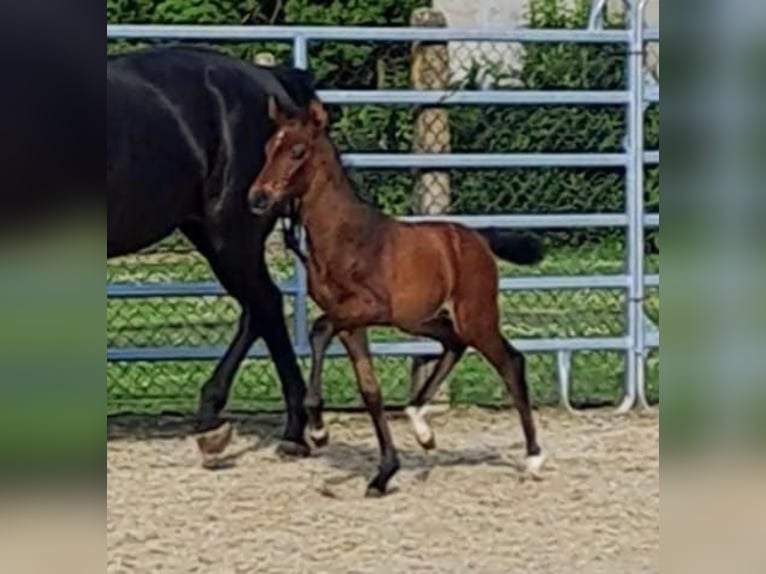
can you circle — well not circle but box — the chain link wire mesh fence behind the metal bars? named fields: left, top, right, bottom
left=107, top=2, right=659, bottom=412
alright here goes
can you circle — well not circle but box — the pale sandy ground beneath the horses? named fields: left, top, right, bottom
left=107, top=409, right=659, bottom=574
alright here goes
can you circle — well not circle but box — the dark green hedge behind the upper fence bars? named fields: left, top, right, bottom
left=107, top=0, right=659, bottom=244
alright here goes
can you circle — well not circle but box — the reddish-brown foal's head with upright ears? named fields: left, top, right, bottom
left=248, top=98, right=327, bottom=215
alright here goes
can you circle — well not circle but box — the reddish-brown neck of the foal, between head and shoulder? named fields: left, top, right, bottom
left=301, top=138, right=382, bottom=257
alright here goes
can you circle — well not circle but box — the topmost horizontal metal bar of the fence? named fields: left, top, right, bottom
left=106, top=24, right=630, bottom=44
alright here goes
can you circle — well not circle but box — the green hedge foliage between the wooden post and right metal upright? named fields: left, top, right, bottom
left=440, top=0, right=640, bottom=244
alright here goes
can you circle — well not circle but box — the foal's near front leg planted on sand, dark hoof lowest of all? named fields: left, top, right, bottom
left=340, top=328, right=399, bottom=496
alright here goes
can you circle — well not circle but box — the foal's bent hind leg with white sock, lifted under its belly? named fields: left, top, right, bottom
left=404, top=317, right=466, bottom=450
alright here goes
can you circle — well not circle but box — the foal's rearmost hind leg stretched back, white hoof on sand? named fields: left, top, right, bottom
left=471, top=330, right=543, bottom=474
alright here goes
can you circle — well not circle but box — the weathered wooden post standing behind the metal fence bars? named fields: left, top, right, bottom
left=410, top=8, right=451, bottom=404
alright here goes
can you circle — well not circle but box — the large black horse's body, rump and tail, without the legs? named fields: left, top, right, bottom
left=106, top=47, right=315, bottom=257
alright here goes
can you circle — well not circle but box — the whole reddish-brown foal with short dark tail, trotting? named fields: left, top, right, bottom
left=249, top=99, right=543, bottom=496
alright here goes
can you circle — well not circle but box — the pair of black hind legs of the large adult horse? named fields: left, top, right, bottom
left=182, top=225, right=309, bottom=462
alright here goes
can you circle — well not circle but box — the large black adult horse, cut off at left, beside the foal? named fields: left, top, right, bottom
left=106, top=46, right=316, bottom=443
